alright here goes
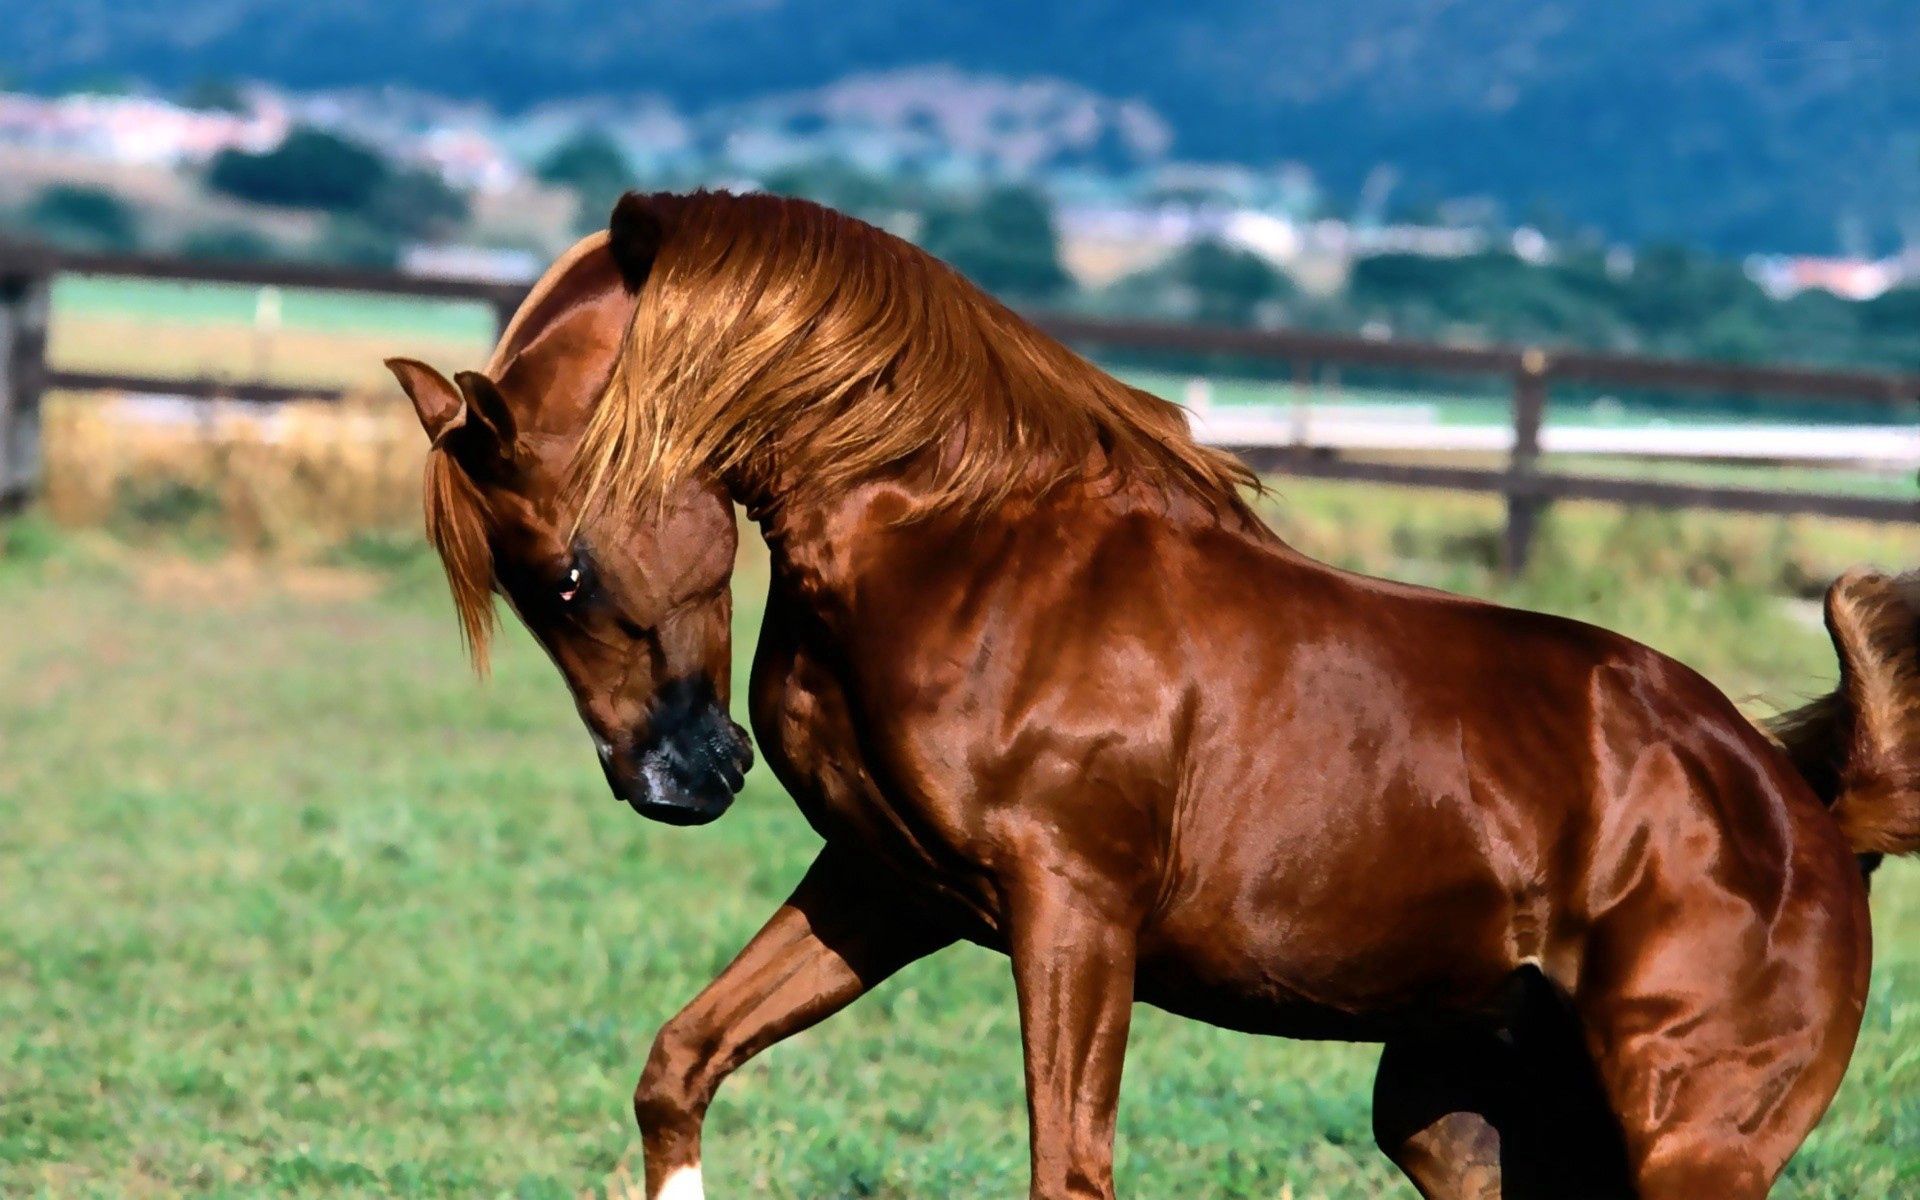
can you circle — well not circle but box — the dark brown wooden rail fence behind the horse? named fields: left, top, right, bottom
left=0, top=244, right=1920, bottom=568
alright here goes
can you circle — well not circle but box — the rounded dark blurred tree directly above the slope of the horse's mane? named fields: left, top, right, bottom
left=920, top=186, right=1069, bottom=300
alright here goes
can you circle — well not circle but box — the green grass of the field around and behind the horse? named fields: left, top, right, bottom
left=0, top=486, right=1920, bottom=1198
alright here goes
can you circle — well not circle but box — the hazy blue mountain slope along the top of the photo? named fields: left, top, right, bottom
left=0, top=0, right=1920, bottom=252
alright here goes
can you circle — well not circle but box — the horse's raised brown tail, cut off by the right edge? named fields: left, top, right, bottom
left=1764, top=570, right=1920, bottom=854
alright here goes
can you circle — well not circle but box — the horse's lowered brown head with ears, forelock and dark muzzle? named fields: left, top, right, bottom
left=388, top=203, right=753, bottom=826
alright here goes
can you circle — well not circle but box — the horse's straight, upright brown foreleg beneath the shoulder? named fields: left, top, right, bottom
left=1006, top=876, right=1137, bottom=1200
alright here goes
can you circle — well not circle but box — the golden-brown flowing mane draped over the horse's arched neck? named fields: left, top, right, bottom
left=576, top=192, right=1258, bottom=513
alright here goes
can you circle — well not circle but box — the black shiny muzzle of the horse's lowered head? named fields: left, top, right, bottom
left=601, top=680, right=753, bottom=826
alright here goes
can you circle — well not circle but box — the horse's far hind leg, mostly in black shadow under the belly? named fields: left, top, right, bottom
left=1373, top=977, right=1632, bottom=1200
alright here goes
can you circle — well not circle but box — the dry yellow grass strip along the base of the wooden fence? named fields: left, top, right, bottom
left=44, top=370, right=1920, bottom=597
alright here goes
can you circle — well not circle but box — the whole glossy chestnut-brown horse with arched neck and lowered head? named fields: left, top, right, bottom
left=378, top=194, right=1920, bottom=1200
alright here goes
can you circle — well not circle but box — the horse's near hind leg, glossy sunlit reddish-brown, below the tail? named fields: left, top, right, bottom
left=1574, top=821, right=1868, bottom=1200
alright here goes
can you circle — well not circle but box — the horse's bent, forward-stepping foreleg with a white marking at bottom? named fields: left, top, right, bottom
left=634, top=847, right=952, bottom=1200
